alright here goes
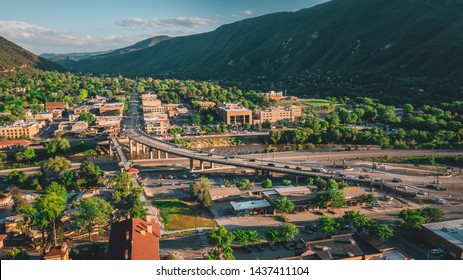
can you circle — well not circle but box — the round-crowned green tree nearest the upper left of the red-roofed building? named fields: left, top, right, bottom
left=74, top=197, right=113, bottom=242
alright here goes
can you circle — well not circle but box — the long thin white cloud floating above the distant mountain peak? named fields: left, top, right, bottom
left=115, top=17, right=215, bottom=29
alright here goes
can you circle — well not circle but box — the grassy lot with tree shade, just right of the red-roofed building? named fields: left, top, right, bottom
left=152, top=199, right=216, bottom=230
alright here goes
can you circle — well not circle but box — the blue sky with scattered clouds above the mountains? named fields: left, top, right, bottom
left=0, top=0, right=328, bottom=54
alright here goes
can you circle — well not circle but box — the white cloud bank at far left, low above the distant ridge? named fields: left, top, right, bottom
left=0, top=20, right=152, bottom=54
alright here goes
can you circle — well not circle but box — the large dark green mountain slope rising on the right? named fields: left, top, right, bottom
left=68, top=0, right=463, bottom=78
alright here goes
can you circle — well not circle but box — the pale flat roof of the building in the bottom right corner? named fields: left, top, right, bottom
left=423, top=219, right=463, bottom=249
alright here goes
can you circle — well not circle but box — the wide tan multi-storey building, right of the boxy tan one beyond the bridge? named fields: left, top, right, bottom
left=254, top=106, right=302, bottom=123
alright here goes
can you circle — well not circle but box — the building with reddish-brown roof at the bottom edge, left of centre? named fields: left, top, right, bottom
left=107, top=215, right=161, bottom=260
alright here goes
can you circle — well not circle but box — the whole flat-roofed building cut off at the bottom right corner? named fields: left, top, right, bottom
left=423, top=219, right=463, bottom=260
